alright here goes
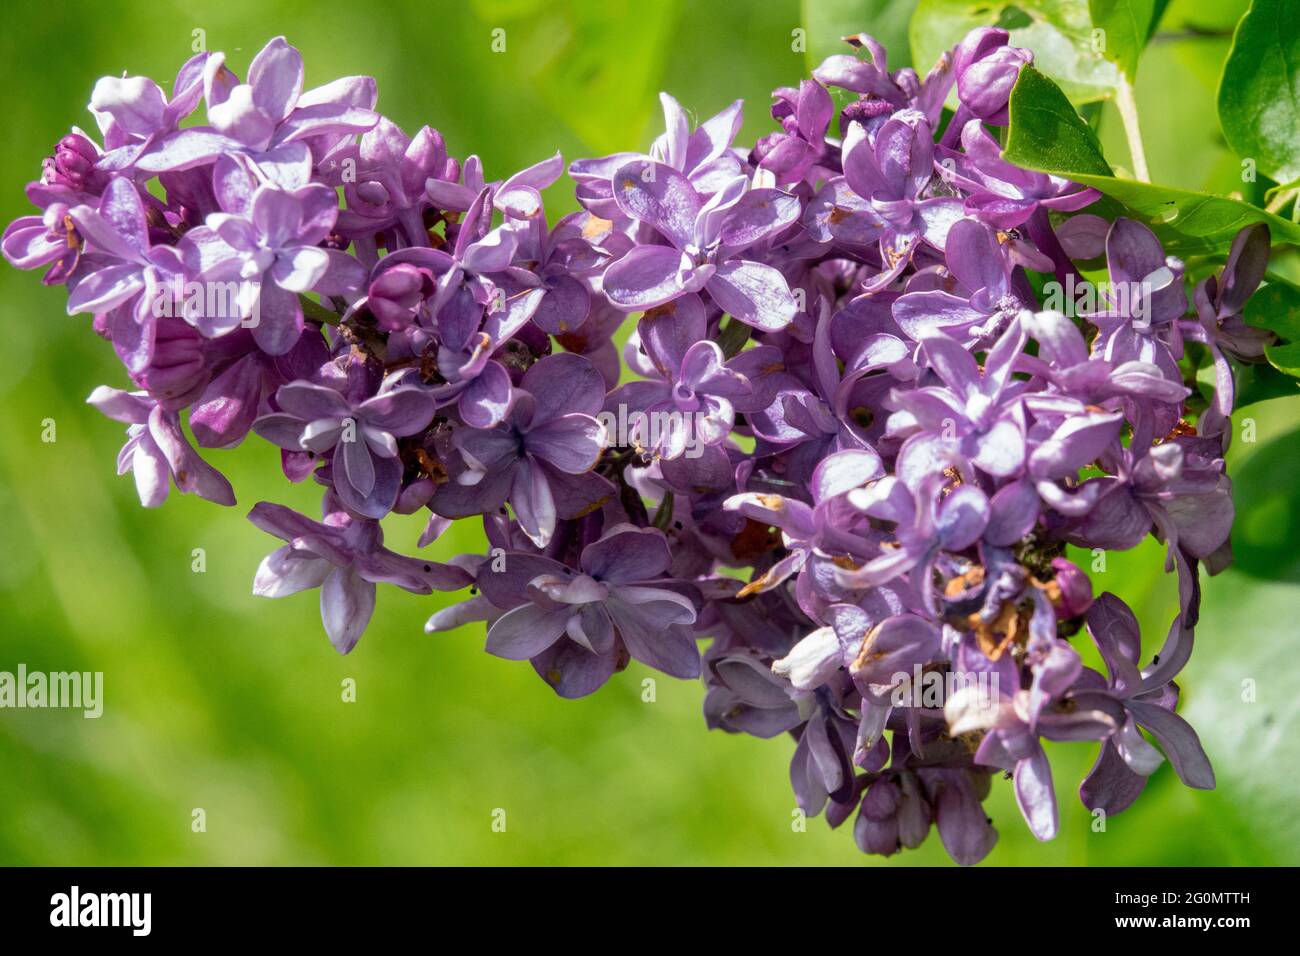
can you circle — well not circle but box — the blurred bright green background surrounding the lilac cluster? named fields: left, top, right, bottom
left=0, top=0, right=1300, bottom=865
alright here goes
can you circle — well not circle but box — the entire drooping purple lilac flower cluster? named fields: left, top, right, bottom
left=3, top=29, right=1269, bottom=864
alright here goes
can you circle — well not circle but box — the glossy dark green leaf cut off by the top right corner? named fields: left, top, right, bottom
left=1218, top=0, right=1300, bottom=182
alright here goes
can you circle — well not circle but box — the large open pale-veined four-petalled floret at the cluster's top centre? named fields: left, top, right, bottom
left=605, top=160, right=800, bottom=332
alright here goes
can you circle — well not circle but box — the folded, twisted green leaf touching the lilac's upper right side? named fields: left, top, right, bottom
left=1002, top=66, right=1300, bottom=256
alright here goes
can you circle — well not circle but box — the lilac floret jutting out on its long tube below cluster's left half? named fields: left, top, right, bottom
left=248, top=497, right=472, bottom=654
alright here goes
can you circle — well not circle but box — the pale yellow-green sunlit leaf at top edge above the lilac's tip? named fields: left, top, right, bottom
left=910, top=0, right=1119, bottom=104
